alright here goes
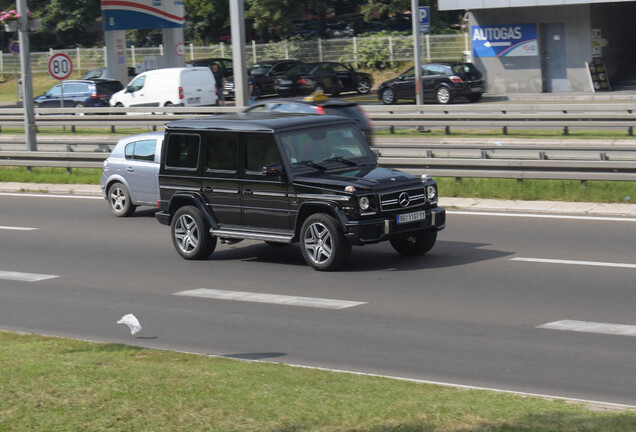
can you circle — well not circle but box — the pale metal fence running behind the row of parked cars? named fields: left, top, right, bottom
left=0, top=34, right=470, bottom=76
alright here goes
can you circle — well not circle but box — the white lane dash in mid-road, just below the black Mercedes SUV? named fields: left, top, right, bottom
left=174, top=288, right=366, bottom=309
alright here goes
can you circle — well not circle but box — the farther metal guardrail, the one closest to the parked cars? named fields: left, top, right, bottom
left=0, top=103, right=636, bottom=136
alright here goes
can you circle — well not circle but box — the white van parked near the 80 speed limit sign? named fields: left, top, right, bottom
left=110, top=67, right=217, bottom=107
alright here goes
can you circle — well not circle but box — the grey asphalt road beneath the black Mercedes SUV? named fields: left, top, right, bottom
left=0, top=194, right=636, bottom=405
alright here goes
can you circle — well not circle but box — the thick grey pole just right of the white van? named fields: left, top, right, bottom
left=230, top=0, right=249, bottom=107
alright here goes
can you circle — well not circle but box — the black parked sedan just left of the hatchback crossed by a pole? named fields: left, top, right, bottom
left=275, top=62, right=373, bottom=96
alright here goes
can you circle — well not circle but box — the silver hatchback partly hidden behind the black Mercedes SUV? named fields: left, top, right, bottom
left=101, top=132, right=164, bottom=217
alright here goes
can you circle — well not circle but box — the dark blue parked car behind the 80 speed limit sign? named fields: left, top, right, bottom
left=33, top=80, right=124, bottom=108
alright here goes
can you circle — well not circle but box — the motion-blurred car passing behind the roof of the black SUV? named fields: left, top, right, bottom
left=243, top=93, right=373, bottom=144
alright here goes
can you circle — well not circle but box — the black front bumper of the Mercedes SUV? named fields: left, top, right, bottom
left=345, top=207, right=446, bottom=245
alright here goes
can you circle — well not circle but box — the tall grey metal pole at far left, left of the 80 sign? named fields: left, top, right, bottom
left=17, top=0, right=38, bottom=151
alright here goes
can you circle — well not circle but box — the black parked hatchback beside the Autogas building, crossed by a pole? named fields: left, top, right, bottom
left=378, top=62, right=486, bottom=104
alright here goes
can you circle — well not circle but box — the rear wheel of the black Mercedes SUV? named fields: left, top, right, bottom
left=170, top=206, right=217, bottom=260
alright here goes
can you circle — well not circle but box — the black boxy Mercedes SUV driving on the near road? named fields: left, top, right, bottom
left=156, top=113, right=446, bottom=270
